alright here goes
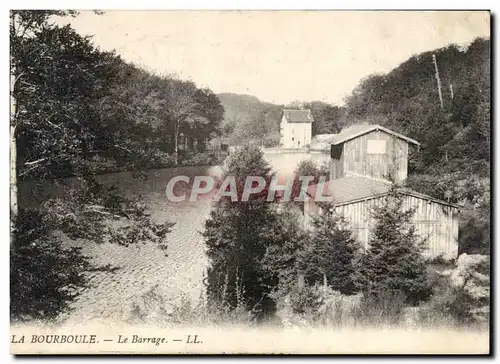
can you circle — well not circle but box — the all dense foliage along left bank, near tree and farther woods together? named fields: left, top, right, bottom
left=10, top=10, right=223, bottom=320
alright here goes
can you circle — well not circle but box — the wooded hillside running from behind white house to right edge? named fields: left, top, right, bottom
left=218, top=39, right=490, bottom=177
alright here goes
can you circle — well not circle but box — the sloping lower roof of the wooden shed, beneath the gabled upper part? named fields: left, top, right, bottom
left=307, top=175, right=459, bottom=208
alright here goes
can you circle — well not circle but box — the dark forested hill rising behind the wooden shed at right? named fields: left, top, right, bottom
left=344, top=39, right=490, bottom=176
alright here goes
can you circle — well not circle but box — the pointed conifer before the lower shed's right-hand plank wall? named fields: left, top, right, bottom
left=357, top=185, right=431, bottom=305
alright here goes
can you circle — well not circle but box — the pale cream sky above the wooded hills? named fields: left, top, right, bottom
left=61, top=10, right=490, bottom=105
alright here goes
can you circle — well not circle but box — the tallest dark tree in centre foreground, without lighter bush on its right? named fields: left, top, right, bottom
left=203, top=146, right=277, bottom=315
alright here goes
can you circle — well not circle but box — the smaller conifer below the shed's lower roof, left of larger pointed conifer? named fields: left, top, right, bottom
left=299, top=207, right=358, bottom=294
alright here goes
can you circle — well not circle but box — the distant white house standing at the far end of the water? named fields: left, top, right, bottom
left=280, top=110, right=314, bottom=149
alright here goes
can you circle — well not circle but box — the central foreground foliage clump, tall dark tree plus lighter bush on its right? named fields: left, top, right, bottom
left=203, top=146, right=303, bottom=318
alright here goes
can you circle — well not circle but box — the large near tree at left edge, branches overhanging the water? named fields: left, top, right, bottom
left=10, top=11, right=171, bottom=320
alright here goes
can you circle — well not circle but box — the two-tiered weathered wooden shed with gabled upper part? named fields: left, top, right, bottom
left=304, top=125, right=459, bottom=259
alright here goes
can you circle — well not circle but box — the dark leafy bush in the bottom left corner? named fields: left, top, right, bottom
left=10, top=209, right=91, bottom=322
